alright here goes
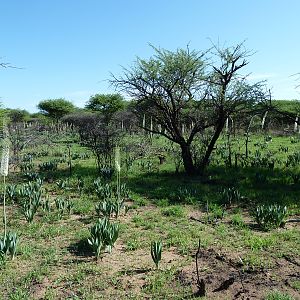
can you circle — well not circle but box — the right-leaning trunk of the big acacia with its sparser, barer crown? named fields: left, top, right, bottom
left=200, top=43, right=269, bottom=170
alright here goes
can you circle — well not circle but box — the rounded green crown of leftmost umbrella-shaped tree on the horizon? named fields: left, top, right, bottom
left=37, top=98, right=76, bottom=121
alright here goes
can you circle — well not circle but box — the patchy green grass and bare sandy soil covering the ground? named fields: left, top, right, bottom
left=0, top=132, right=300, bottom=299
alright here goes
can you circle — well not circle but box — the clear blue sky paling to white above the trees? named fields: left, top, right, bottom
left=0, top=0, right=300, bottom=112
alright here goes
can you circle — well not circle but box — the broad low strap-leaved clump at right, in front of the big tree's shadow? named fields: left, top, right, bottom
left=253, top=204, right=288, bottom=230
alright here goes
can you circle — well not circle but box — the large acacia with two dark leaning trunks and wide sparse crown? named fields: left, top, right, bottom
left=111, top=44, right=264, bottom=174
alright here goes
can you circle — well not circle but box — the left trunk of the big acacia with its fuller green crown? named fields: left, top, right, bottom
left=112, top=48, right=205, bottom=174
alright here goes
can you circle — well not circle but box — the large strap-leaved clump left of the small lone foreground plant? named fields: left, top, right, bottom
left=88, top=218, right=119, bottom=259
